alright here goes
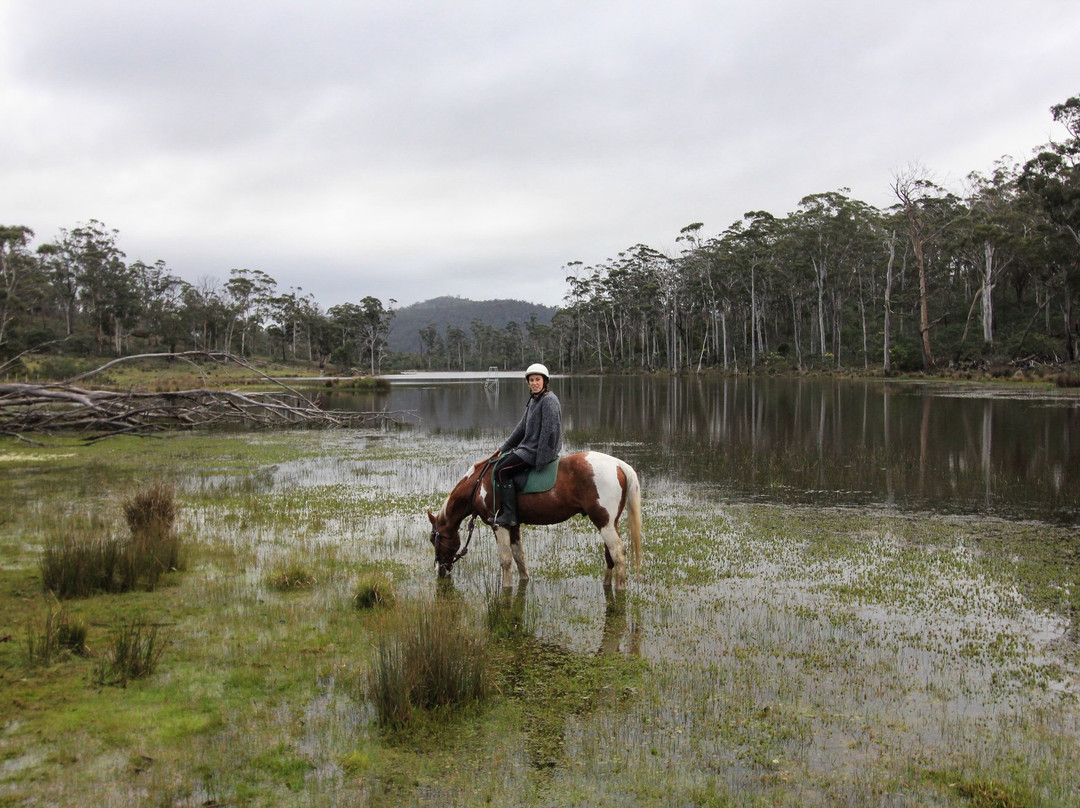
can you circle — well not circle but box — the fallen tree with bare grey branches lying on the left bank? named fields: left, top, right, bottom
left=0, top=351, right=409, bottom=441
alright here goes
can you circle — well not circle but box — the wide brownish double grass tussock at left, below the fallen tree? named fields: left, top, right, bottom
left=39, top=483, right=184, bottom=598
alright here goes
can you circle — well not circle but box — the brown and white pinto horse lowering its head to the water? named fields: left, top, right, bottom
left=428, top=452, right=642, bottom=589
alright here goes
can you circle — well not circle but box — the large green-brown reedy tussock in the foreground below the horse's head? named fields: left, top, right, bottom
left=368, top=602, right=491, bottom=729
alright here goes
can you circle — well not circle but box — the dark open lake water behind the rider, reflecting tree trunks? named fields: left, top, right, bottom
left=325, top=374, right=1080, bottom=524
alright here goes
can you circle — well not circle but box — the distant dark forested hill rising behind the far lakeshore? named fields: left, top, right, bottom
left=390, top=297, right=557, bottom=353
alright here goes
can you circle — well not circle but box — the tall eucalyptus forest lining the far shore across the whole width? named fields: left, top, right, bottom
left=0, top=96, right=1080, bottom=374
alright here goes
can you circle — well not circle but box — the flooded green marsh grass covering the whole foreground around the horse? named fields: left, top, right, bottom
left=0, top=432, right=1080, bottom=808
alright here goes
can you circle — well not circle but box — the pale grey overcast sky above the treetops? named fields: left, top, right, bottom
left=0, top=0, right=1080, bottom=308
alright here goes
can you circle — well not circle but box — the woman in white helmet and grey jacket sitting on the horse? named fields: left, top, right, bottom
left=491, top=362, right=563, bottom=527
